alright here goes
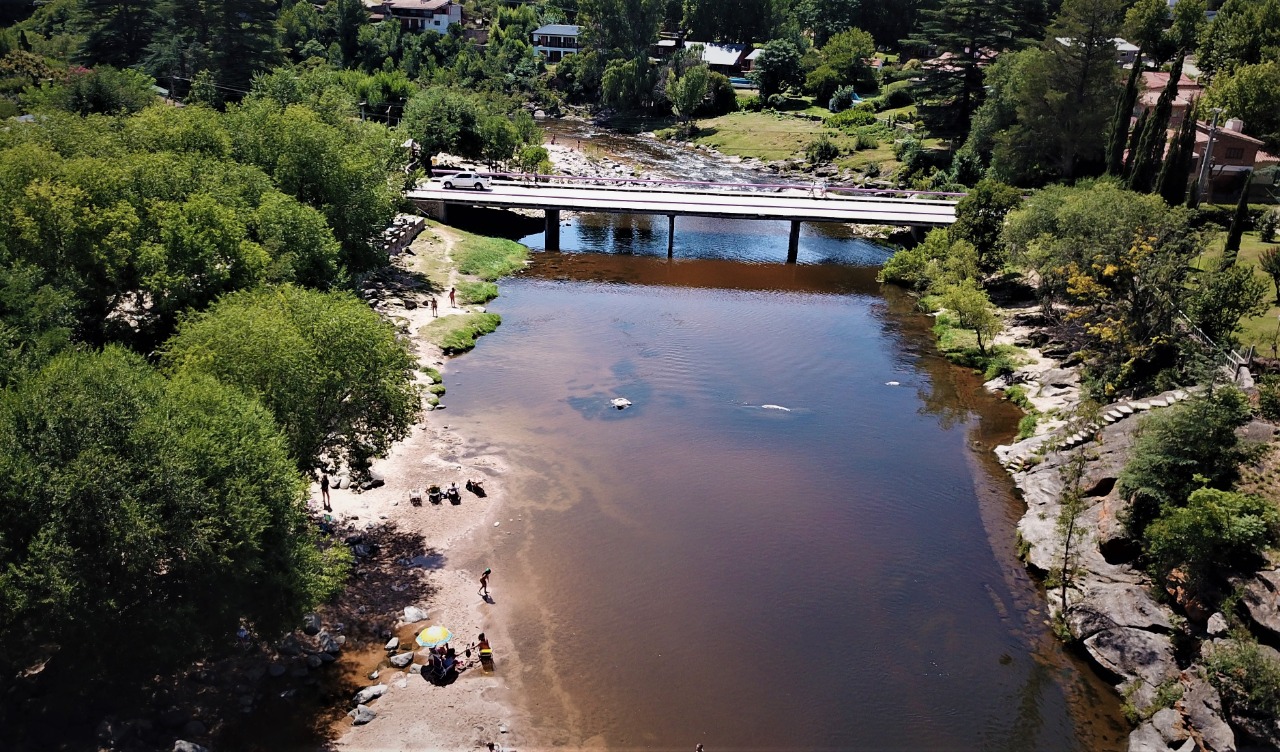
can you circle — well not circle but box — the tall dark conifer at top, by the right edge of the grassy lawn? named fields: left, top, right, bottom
left=902, top=0, right=1021, bottom=134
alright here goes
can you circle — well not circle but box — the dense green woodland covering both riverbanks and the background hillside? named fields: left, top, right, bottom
left=0, top=0, right=1280, bottom=740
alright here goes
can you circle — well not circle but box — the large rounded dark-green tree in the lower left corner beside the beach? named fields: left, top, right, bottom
left=0, top=348, right=340, bottom=677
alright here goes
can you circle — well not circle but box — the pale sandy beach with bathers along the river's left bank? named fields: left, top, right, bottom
left=327, top=225, right=530, bottom=749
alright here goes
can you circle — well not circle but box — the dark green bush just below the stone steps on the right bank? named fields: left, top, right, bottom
left=1116, top=388, right=1252, bottom=540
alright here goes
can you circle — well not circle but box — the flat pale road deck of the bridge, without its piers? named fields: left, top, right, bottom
left=406, top=182, right=956, bottom=226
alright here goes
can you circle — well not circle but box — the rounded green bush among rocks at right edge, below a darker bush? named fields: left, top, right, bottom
left=1146, top=489, right=1280, bottom=586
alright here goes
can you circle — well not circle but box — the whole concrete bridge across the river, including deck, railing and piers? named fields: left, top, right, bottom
left=406, top=175, right=961, bottom=263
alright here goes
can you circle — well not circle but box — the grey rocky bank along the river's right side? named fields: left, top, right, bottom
left=987, top=308, right=1280, bottom=752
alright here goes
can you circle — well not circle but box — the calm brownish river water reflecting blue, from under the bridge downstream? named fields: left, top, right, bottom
left=448, top=155, right=1126, bottom=752
